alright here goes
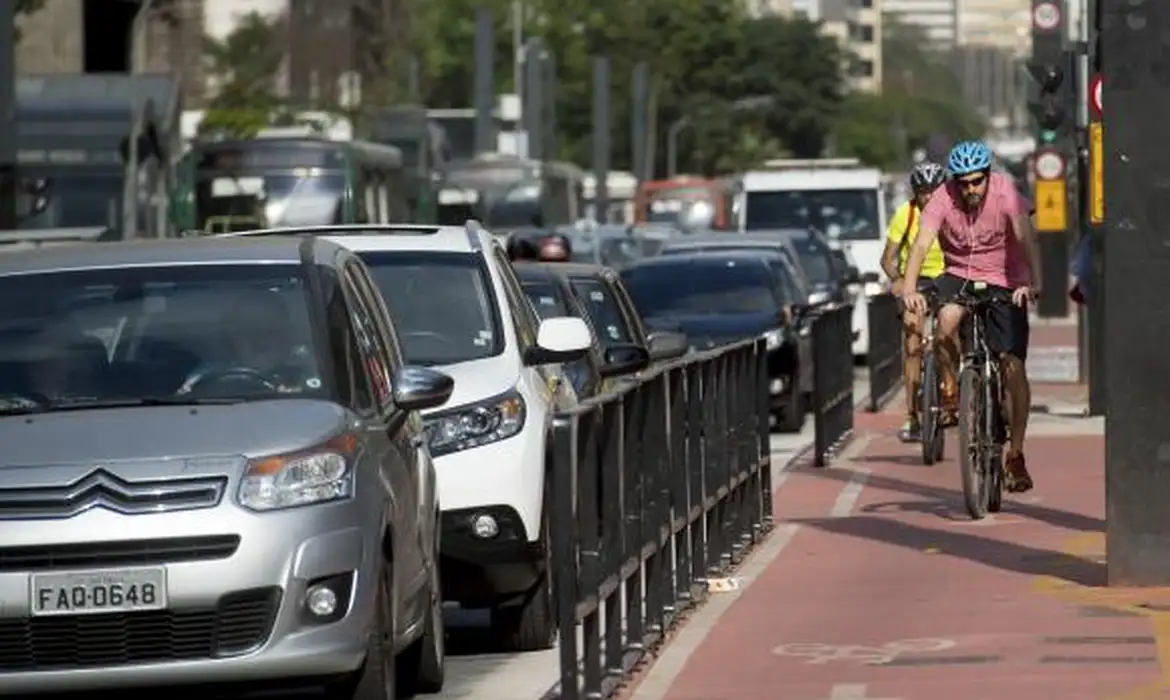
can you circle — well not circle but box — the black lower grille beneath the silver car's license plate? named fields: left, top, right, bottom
left=0, top=588, right=281, bottom=674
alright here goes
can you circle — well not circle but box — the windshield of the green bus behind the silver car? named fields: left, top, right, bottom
left=195, top=169, right=345, bottom=233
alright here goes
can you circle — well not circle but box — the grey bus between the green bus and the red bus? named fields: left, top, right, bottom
left=439, top=153, right=585, bottom=231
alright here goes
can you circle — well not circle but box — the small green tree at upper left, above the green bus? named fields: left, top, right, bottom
left=199, top=12, right=285, bottom=138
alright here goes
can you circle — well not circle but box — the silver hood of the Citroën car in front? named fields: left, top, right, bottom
left=0, top=399, right=351, bottom=480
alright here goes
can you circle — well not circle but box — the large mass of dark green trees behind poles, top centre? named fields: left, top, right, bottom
left=413, top=0, right=841, bottom=173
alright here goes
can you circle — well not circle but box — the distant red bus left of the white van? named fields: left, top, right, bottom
left=634, top=177, right=731, bottom=231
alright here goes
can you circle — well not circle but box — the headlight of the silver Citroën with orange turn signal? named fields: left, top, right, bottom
left=238, top=434, right=358, bottom=510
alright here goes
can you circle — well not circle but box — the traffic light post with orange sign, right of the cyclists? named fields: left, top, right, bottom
left=1027, top=0, right=1073, bottom=317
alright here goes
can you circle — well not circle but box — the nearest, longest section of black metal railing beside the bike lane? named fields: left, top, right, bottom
left=549, top=341, right=772, bottom=700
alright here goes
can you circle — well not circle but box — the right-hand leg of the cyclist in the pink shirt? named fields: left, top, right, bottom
left=987, top=307, right=1033, bottom=493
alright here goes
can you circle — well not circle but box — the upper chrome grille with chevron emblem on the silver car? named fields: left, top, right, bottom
left=0, top=469, right=227, bottom=520
